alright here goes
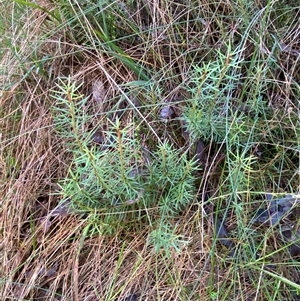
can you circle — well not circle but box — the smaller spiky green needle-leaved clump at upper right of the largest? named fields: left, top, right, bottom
left=182, top=48, right=242, bottom=142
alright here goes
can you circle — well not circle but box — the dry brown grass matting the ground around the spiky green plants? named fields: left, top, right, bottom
left=0, top=1, right=299, bottom=301
